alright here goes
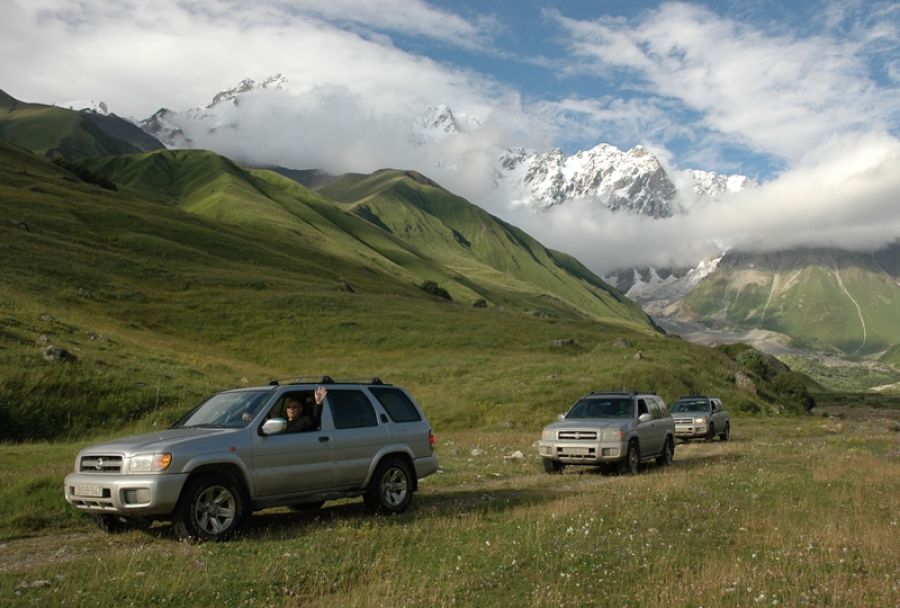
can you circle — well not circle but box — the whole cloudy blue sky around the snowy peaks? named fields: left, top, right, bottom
left=0, top=0, right=900, bottom=270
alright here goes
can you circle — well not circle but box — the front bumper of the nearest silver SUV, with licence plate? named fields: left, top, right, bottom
left=65, top=473, right=187, bottom=517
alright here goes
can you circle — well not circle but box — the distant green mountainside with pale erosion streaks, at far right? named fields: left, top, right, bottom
left=684, top=255, right=900, bottom=356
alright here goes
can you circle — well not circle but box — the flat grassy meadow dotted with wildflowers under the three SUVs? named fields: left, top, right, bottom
left=0, top=416, right=900, bottom=607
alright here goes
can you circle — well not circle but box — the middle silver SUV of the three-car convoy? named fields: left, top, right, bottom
left=538, top=393, right=675, bottom=474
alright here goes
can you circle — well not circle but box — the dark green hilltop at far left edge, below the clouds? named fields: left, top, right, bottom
left=0, top=91, right=138, bottom=159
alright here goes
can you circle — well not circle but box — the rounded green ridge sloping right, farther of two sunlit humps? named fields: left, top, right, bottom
left=320, top=170, right=649, bottom=325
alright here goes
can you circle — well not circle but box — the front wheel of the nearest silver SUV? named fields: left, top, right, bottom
left=172, top=473, right=247, bottom=542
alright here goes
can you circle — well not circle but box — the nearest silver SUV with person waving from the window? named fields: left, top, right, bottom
left=65, top=376, right=438, bottom=540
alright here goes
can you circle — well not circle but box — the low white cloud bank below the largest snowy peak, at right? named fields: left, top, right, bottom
left=516, top=135, right=900, bottom=273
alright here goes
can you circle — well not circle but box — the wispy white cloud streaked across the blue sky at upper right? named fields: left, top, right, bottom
left=557, top=3, right=898, bottom=161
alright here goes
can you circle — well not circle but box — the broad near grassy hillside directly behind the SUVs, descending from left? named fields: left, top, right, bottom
left=0, top=140, right=780, bottom=437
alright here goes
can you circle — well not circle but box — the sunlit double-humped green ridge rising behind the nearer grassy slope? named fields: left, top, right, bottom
left=86, top=150, right=652, bottom=329
